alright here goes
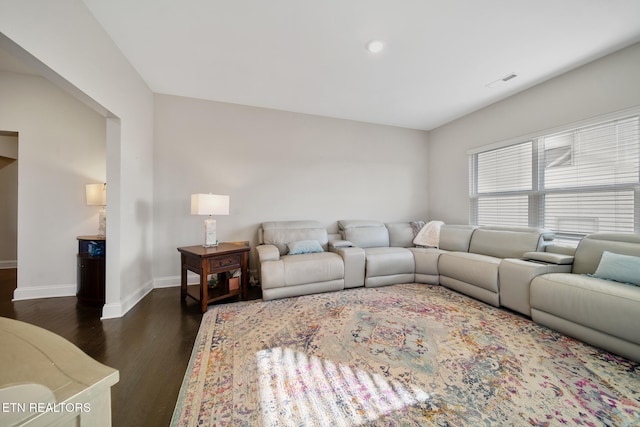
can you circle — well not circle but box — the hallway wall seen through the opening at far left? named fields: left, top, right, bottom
left=0, top=72, right=106, bottom=299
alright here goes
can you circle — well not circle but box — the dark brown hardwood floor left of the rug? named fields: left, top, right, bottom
left=0, top=269, right=260, bottom=426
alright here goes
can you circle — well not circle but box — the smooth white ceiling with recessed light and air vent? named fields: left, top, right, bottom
left=0, top=0, right=640, bottom=130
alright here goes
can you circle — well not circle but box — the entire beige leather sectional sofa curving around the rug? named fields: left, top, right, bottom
left=257, top=220, right=640, bottom=361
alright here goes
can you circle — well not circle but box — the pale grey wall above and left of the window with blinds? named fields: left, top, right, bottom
left=428, top=43, right=640, bottom=224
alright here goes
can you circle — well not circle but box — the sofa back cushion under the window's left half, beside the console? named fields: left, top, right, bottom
left=469, top=226, right=553, bottom=258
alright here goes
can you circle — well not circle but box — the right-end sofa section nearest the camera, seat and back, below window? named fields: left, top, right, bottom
left=529, top=233, right=640, bottom=362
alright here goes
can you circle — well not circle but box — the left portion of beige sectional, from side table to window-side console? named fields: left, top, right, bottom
left=257, top=220, right=552, bottom=306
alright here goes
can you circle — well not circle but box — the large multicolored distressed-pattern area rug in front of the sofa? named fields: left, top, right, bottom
left=171, top=284, right=640, bottom=426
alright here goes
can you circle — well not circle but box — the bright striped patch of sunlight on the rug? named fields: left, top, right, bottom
left=257, top=347, right=429, bottom=426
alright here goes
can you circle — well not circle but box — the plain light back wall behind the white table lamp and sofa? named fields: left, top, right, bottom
left=153, top=95, right=427, bottom=285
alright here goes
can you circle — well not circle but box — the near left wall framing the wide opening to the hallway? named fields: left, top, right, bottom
left=0, top=0, right=153, bottom=317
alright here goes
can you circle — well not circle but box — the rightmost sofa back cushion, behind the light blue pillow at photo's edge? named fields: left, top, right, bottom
left=572, top=233, right=640, bottom=274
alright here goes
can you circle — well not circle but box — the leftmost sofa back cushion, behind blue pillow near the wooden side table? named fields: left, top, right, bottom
left=258, top=221, right=329, bottom=255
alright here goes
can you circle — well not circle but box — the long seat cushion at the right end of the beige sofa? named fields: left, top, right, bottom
left=531, top=273, right=640, bottom=344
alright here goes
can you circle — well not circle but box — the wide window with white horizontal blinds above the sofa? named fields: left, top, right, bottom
left=469, top=112, right=640, bottom=244
